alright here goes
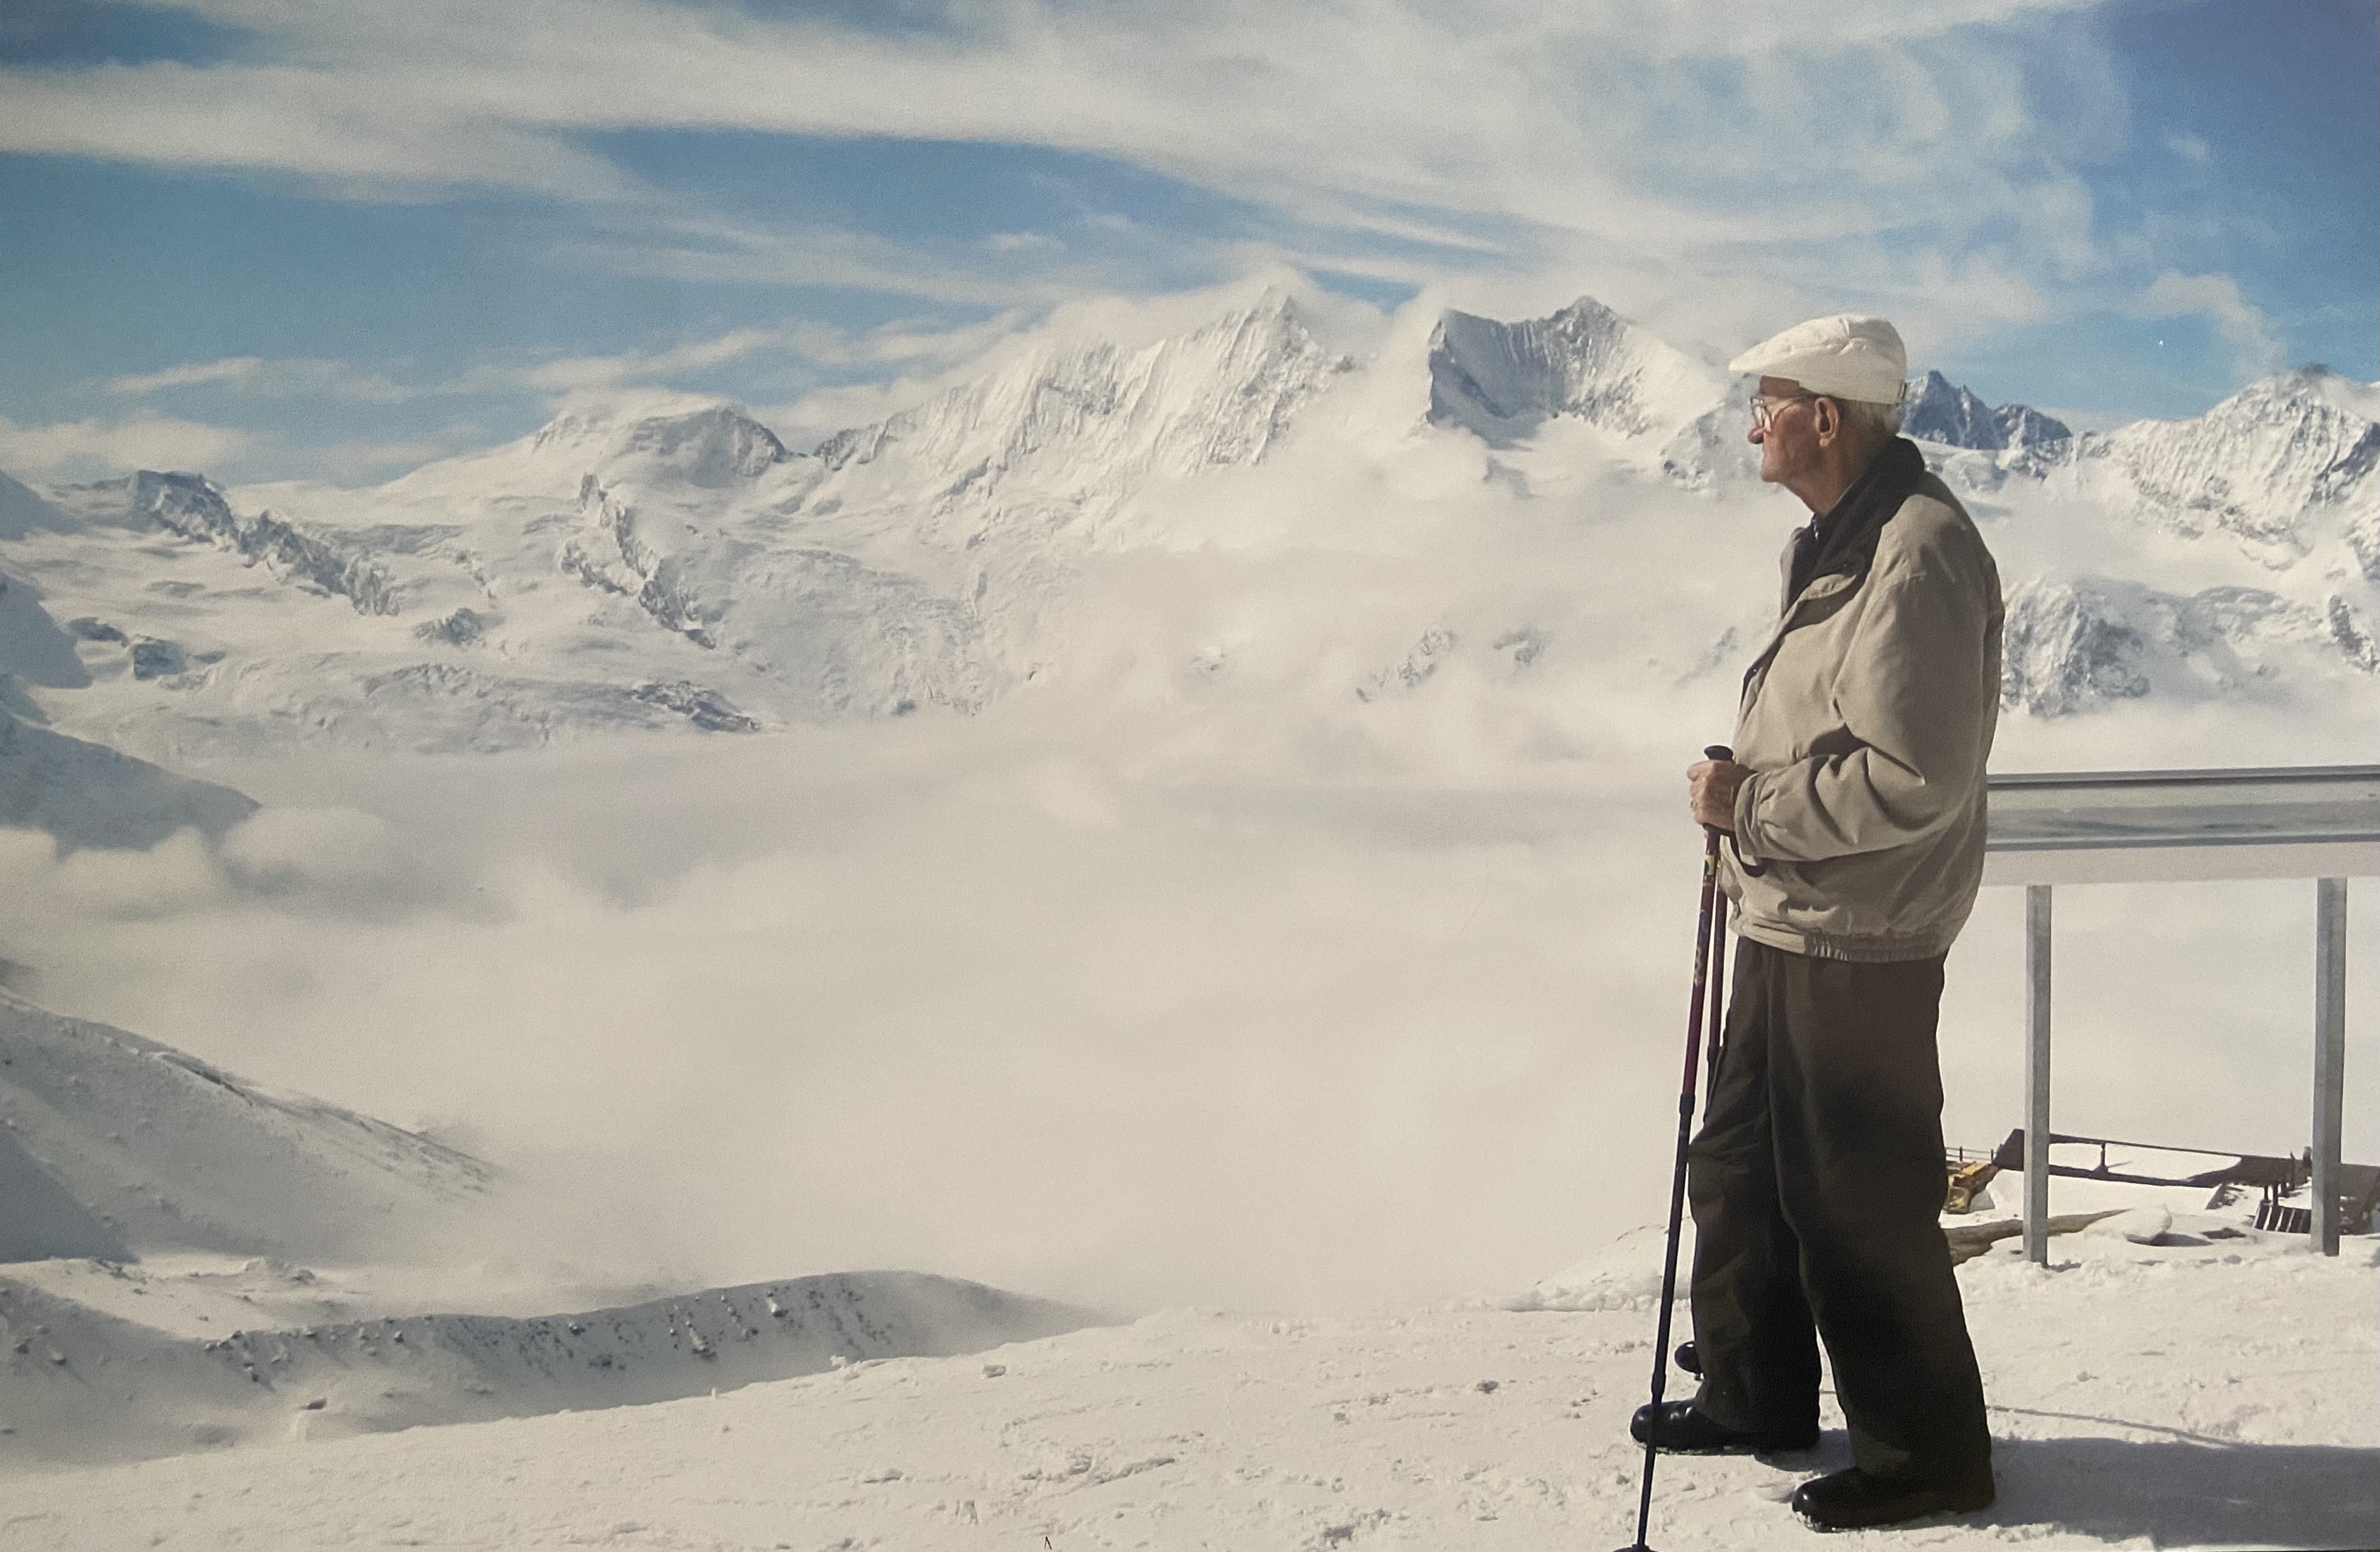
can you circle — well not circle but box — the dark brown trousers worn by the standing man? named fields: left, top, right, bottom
left=1687, top=940, right=1992, bottom=1483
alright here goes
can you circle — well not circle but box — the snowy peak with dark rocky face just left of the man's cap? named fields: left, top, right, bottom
left=1428, top=297, right=1728, bottom=447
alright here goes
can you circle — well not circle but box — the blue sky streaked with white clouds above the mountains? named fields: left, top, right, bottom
left=0, top=0, right=2380, bottom=481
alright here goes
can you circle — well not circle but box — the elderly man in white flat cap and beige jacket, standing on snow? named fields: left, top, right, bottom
left=1635, top=317, right=2002, bottom=1531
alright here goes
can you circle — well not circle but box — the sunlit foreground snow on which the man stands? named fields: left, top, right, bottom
left=0, top=1235, right=2380, bottom=1550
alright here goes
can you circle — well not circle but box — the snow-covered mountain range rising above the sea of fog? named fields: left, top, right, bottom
left=0, top=293, right=2380, bottom=790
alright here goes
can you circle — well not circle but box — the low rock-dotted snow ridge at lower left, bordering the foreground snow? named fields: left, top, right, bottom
left=0, top=1264, right=1100, bottom=1464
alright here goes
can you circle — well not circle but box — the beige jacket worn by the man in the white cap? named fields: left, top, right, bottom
left=1725, top=473, right=2002, bottom=962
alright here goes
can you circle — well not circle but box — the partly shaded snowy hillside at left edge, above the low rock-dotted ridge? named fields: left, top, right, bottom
left=0, top=990, right=493, bottom=1259
